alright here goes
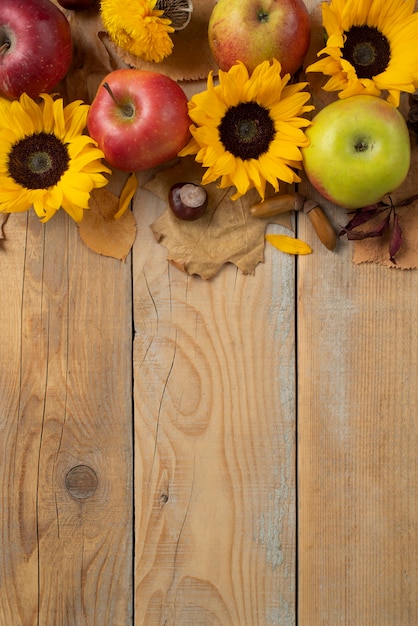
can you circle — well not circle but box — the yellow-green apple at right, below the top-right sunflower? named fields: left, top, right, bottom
left=302, top=95, right=411, bottom=209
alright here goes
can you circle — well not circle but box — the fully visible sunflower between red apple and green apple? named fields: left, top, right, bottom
left=179, top=59, right=313, bottom=200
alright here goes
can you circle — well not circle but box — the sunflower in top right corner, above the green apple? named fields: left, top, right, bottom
left=306, top=0, right=418, bottom=107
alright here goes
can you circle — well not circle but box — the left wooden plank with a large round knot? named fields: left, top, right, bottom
left=0, top=213, right=132, bottom=626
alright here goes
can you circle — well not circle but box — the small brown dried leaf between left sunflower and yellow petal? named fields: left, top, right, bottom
left=77, top=187, right=136, bottom=261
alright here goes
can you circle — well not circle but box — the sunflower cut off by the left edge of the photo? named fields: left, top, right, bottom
left=0, top=93, right=110, bottom=222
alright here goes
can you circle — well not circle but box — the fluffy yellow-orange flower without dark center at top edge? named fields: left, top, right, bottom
left=100, top=0, right=174, bottom=63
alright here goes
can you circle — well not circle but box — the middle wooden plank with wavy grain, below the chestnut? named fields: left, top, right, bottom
left=133, top=183, right=295, bottom=626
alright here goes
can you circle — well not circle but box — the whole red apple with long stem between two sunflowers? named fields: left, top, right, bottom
left=87, top=68, right=191, bottom=172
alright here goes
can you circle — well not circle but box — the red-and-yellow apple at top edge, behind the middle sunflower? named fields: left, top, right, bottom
left=208, top=0, right=311, bottom=75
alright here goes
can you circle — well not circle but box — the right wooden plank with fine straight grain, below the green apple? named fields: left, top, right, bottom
left=298, top=201, right=418, bottom=626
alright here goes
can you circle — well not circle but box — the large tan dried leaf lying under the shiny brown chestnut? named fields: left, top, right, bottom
left=144, top=158, right=290, bottom=279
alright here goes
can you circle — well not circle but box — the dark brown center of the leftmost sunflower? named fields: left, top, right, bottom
left=8, top=132, right=70, bottom=189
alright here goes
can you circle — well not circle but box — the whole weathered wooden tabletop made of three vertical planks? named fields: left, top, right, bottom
left=0, top=3, right=418, bottom=626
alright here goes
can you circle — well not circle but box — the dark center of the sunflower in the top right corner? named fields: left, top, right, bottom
left=343, top=26, right=390, bottom=79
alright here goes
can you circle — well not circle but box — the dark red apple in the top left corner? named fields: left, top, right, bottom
left=0, top=0, right=73, bottom=98
